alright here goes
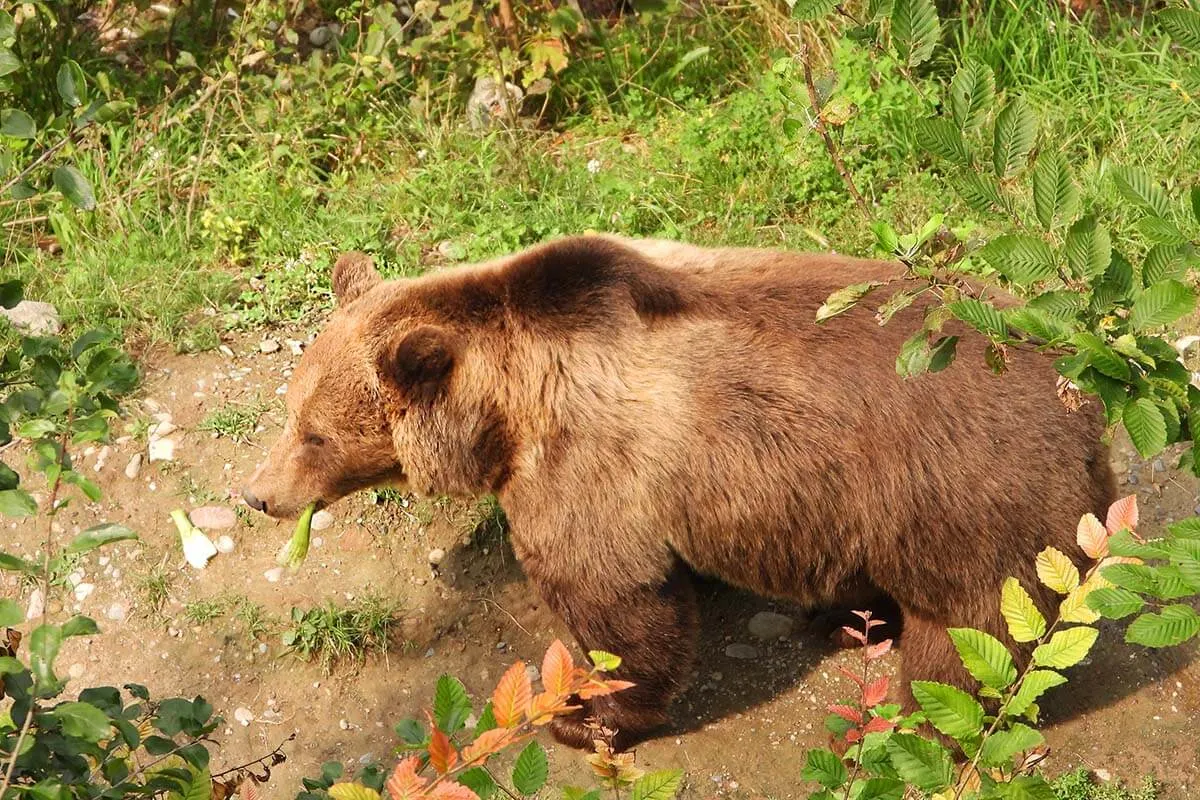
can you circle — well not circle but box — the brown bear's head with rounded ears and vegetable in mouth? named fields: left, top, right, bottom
left=242, top=253, right=511, bottom=518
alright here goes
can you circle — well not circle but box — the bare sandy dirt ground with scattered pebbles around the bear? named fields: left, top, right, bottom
left=0, top=331, right=1200, bottom=799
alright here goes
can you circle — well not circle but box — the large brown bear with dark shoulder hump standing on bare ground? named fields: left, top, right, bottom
left=245, top=235, right=1115, bottom=747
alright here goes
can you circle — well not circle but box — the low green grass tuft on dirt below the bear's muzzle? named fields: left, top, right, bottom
left=282, top=595, right=398, bottom=673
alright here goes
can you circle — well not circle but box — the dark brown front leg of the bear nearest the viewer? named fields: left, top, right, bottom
left=530, top=560, right=698, bottom=751
